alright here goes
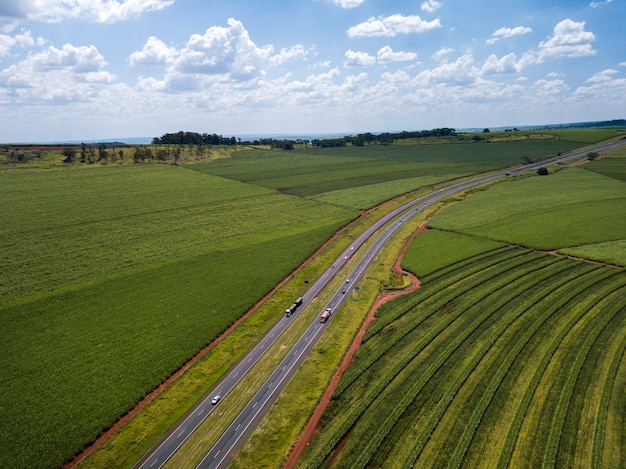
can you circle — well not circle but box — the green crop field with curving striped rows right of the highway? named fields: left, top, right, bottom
left=304, top=247, right=626, bottom=468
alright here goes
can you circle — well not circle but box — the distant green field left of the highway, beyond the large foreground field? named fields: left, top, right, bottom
left=194, top=138, right=580, bottom=209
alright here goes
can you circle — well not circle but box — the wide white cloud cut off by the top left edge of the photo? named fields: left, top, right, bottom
left=2, top=0, right=174, bottom=23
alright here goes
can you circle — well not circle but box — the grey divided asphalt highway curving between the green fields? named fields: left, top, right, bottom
left=135, top=140, right=626, bottom=469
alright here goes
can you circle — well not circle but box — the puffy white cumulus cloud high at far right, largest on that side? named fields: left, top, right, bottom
left=537, top=19, right=596, bottom=62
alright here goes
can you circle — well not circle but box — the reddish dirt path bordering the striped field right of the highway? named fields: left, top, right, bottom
left=283, top=225, right=426, bottom=469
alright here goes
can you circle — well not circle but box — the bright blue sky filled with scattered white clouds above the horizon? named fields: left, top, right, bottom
left=0, top=0, right=626, bottom=142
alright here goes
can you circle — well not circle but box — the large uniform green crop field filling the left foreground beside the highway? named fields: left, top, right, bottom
left=0, top=165, right=356, bottom=467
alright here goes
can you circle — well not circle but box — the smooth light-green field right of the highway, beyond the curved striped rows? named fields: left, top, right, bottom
left=429, top=168, right=626, bottom=249
